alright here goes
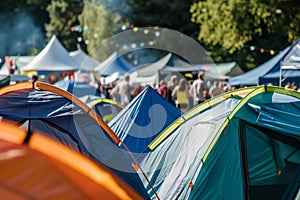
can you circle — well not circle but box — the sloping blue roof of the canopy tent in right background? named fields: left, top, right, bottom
left=229, top=47, right=291, bottom=86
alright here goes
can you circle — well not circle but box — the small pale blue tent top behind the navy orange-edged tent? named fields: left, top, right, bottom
left=53, top=80, right=100, bottom=98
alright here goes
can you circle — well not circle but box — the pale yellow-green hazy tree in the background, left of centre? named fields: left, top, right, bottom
left=79, top=0, right=121, bottom=59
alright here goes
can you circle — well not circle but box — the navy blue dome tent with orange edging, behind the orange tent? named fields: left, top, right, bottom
left=0, top=82, right=147, bottom=198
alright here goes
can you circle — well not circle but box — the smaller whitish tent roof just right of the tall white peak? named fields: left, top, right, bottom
left=69, top=48, right=100, bottom=71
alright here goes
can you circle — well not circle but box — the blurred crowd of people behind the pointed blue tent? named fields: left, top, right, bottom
left=97, top=71, right=235, bottom=112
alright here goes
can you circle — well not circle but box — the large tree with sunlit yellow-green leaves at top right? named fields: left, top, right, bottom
left=190, top=0, right=300, bottom=68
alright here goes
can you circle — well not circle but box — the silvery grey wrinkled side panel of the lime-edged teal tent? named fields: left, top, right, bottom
left=140, top=99, right=238, bottom=200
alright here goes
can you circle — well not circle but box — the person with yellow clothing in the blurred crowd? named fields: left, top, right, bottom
left=172, top=78, right=189, bottom=113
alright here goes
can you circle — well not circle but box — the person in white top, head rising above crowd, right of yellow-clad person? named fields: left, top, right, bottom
left=190, top=71, right=208, bottom=106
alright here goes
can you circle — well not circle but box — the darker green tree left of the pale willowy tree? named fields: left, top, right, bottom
left=45, top=0, right=83, bottom=50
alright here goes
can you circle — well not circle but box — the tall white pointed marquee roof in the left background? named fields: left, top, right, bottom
left=22, top=35, right=80, bottom=71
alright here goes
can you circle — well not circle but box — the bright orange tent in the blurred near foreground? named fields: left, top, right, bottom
left=0, top=119, right=143, bottom=199
